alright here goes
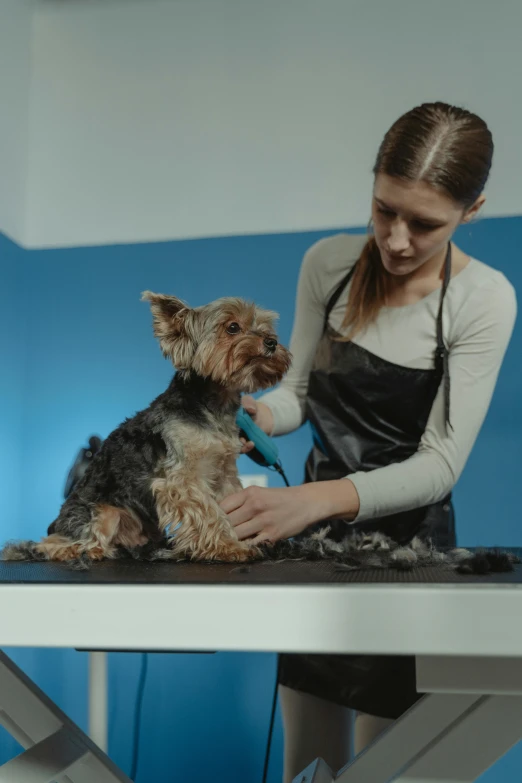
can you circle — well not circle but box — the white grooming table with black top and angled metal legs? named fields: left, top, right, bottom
left=0, top=550, right=522, bottom=783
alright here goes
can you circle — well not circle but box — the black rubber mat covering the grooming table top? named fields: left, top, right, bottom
left=0, top=548, right=522, bottom=591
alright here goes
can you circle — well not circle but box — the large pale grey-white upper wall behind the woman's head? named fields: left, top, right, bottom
left=4, top=0, right=522, bottom=247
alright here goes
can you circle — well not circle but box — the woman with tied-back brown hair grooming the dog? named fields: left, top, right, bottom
left=217, top=103, right=516, bottom=781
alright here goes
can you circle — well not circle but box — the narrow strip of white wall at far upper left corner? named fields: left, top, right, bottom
left=0, top=0, right=34, bottom=239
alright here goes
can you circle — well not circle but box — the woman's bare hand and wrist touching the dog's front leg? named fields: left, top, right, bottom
left=220, top=479, right=359, bottom=544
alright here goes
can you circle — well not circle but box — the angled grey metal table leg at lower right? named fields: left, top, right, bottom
left=294, top=657, right=522, bottom=783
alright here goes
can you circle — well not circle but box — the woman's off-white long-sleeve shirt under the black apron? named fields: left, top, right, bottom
left=260, top=234, right=517, bottom=521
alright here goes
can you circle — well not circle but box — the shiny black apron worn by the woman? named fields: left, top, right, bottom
left=278, top=244, right=455, bottom=719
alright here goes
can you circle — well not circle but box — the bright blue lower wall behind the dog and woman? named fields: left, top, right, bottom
left=0, top=218, right=522, bottom=783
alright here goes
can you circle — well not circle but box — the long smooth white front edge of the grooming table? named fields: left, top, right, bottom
left=0, top=583, right=522, bottom=657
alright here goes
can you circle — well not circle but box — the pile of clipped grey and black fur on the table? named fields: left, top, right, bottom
left=263, top=528, right=520, bottom=576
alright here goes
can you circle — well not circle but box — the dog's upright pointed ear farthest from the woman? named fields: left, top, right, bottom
left=141, top=291, right=196, bottom=370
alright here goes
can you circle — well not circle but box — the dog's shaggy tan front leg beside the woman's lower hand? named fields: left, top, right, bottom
left=152, top=472, right=260, bottom=562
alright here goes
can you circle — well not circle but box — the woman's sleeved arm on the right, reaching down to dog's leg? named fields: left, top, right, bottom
left=222, top=272, right=517, bottom=542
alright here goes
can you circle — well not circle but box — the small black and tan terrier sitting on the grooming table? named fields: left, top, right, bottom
left=2, top=291, right=291, bottom=565
